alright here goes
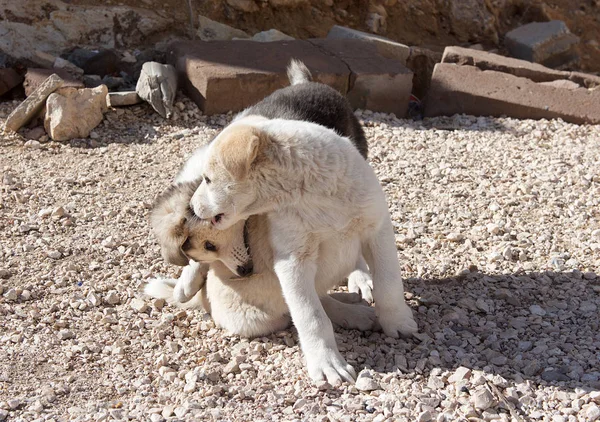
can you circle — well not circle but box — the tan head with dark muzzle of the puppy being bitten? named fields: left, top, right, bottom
left=150, top=183, right=253, bottom=277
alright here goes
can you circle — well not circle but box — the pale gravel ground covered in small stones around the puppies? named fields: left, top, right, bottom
left=0, top=98, right=600, bottom=422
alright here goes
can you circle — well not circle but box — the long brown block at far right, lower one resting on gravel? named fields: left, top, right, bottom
left=425, top=63, right=600, bottom=124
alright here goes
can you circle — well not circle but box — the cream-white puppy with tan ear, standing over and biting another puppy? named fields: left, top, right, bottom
left=190, top=116, right=417, bottom=384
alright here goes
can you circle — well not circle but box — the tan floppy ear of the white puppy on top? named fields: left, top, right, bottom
left=218, top=126, right=268, bottom=180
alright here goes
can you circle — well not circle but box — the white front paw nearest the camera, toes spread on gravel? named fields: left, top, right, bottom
left=306, top=348, right=356, bottom=386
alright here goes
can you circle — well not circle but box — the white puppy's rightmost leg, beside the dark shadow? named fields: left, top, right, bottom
left=362, top=213, right=417, bottom=338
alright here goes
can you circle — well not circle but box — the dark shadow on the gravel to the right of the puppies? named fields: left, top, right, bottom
left=336, top=272, right=600, bottom=391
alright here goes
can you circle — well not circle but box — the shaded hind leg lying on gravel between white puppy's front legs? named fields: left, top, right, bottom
left=321, top=295, right=377, bottom=331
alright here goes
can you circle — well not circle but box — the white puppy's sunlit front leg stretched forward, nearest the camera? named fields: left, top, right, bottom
left=272, top=227, right=356, bottom=385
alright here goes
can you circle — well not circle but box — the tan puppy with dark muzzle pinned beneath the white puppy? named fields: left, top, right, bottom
left=145, top=183, right=378, bottom=337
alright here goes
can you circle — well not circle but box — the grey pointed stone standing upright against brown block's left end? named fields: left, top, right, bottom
left=135, top=62, right=177, bottom=118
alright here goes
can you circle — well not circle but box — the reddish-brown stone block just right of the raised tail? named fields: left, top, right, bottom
left=309, top=39, right=413, bottom=117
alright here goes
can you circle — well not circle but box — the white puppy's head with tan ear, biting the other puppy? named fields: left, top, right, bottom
left=190, top=123, right=269, bottom=230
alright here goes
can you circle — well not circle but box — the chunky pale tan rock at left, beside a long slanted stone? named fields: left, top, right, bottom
left=44, top=85, right=108, bottom=141
